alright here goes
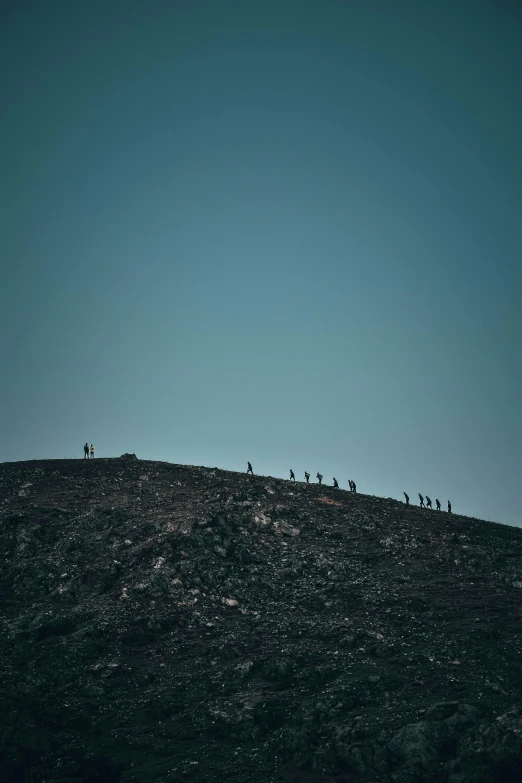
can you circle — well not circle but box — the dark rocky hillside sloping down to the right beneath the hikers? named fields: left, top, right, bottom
left=0, top=455, right=522, bottom=783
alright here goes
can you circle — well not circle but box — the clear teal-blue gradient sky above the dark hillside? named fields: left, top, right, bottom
left=0, top=0, right=522, bottom=525
